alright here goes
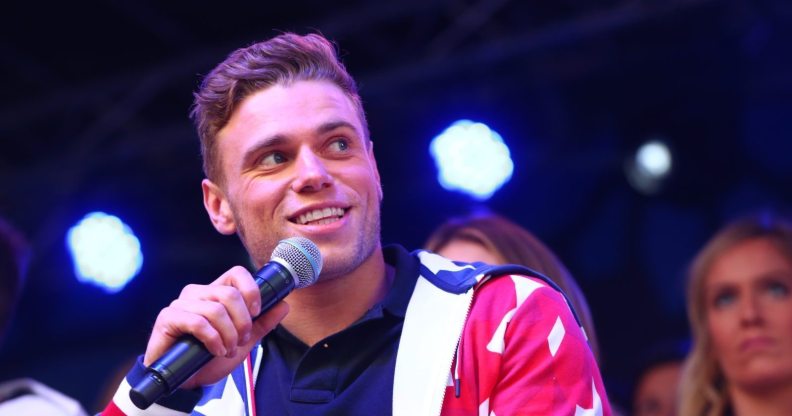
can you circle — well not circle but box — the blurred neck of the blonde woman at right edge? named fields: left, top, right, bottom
left=729, top=383, right=792, bottom=416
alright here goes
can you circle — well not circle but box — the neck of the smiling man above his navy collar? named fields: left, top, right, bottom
left=281, top=248, right=393, bottom=346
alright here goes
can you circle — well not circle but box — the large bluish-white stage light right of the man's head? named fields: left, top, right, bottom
left=429, top=120, right=514, bottom=200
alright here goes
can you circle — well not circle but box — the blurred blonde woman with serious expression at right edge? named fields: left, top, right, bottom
left=680, top=215, right=792, bottom=416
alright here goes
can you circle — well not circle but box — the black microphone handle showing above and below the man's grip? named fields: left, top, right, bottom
left=129, top=261, right=295, bottom=409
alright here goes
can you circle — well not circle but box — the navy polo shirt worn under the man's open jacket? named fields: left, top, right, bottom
left=255, top=245, right=418, bottom=416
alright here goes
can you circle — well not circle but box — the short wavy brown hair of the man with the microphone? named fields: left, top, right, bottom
left=190, top=33, right=369, bottom=180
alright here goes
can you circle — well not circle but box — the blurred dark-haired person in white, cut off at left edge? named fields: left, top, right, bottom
left=0, top=218, right=86, bottom=416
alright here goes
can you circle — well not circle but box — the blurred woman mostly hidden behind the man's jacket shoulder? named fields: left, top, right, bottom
left=424, top=213, right=599, bottom=361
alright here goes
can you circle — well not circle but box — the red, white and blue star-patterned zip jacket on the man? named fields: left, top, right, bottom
left=102, top=251, right=611, bottom=416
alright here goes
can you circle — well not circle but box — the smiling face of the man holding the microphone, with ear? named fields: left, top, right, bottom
left=203, top=81, right=382, bottom=279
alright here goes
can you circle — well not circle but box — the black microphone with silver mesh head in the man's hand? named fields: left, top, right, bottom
left=129, top=237, right=322, bottom=409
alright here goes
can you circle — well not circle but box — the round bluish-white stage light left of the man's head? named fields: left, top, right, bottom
left=66, top=212, right=143, bottom=293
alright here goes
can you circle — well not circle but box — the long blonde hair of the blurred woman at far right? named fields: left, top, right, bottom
left=679, top=214, right=792, bottom=416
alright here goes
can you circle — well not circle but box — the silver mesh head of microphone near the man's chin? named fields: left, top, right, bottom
left=270, top=237, right=322, bottom=289
